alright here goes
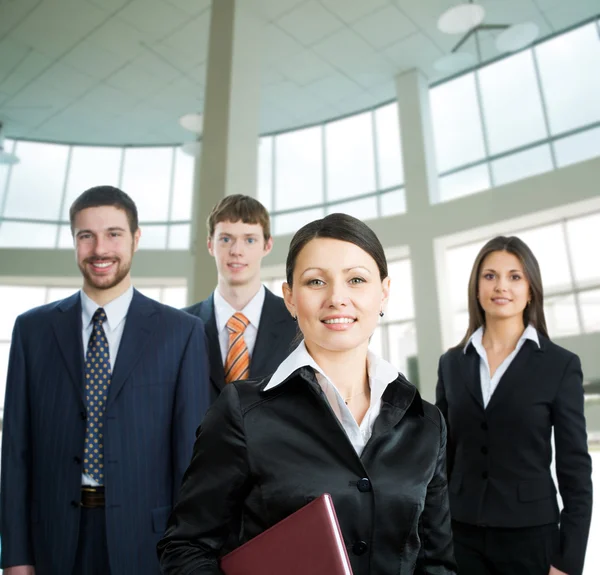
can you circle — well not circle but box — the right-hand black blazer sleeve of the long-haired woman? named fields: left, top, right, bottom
left=552, top=356, right=592, bottom=575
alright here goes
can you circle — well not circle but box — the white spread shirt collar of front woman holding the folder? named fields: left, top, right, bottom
left=264, top=341, right=398, bottom=399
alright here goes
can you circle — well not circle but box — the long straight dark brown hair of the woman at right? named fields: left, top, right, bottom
left=458, top=236, right=548, bottom=347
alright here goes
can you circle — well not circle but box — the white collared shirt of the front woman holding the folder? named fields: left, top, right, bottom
left=265, top=341, right=398, bottom=456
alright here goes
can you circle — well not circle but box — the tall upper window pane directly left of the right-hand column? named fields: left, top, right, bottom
left=374, top=102, right=404, bottom=189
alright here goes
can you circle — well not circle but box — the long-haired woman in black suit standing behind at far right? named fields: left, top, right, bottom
left=436, top=237, right=592, bottom=575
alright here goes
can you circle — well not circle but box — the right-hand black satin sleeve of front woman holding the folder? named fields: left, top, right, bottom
left=414, top=414, right=456, bottom=575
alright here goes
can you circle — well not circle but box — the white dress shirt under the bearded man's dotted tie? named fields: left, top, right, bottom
left=80, top=286, right=133, bottom=486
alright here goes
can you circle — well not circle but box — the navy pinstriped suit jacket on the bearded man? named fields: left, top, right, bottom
left=0, top=291, right=208, bottom=575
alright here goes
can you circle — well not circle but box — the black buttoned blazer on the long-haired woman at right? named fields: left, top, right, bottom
left=436, top=334, right=592, bottom=575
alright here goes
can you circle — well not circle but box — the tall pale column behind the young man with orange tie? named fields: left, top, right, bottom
left=188, top=0, right=263, bottom=303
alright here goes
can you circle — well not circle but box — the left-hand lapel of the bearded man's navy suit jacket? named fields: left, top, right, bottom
left=52, top=292, right=84, bottom=404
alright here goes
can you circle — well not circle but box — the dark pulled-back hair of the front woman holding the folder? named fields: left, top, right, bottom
left=285, top=214, right=388, bottom=287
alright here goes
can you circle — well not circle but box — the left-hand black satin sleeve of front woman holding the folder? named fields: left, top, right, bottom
left=158, top=384, right=249, bottom=575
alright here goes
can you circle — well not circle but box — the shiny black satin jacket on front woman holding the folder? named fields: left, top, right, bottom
left=159, top=367, right=456, bottom=575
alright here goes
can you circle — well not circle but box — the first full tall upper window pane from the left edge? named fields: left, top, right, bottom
left=3, top=142, right=69, bottom=220
